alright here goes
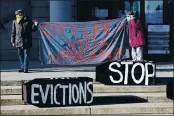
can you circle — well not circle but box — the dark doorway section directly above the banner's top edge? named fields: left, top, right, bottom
left=77, top=0, right=129, bottom=21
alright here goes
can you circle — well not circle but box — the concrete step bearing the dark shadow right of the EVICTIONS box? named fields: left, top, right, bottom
left=1, top=93, right=173, bottom=105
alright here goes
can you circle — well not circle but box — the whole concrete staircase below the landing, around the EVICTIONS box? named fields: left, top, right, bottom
left=1, top=63, right=173, bottom=115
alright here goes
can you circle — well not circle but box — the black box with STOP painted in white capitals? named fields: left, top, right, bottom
left=96, top=61, right=156, bottom=85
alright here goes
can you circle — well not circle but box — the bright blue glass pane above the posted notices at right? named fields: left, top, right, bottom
left=145, top=0, right=163, bottom=24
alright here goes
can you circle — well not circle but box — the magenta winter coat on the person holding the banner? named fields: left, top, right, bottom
left=128, top=19, right=145, bottom=47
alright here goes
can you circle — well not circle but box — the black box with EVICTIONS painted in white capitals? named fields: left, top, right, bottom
left=23, top=77, right=93, bottom=106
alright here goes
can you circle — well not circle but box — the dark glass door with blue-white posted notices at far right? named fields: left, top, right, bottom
left=144, top=0, right=174, bottom=61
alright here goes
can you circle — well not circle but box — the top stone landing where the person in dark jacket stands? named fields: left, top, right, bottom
left=1, top=61, right=174, bottom=80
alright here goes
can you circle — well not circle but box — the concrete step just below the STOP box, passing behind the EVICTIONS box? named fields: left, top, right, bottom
left=1, top=84, right=166, bottom=95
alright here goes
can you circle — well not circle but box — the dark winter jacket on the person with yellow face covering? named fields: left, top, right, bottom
left=11, top=16, right=37, bottom=48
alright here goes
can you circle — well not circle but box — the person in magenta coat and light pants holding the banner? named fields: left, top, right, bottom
left=127, top=11, right=145, bottom=61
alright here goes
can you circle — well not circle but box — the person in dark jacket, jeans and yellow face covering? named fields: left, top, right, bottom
left=11, top=10, right=38, bottom=73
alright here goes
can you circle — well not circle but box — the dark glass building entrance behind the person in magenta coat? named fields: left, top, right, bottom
left=77, top=0, right=174, bottom=61
